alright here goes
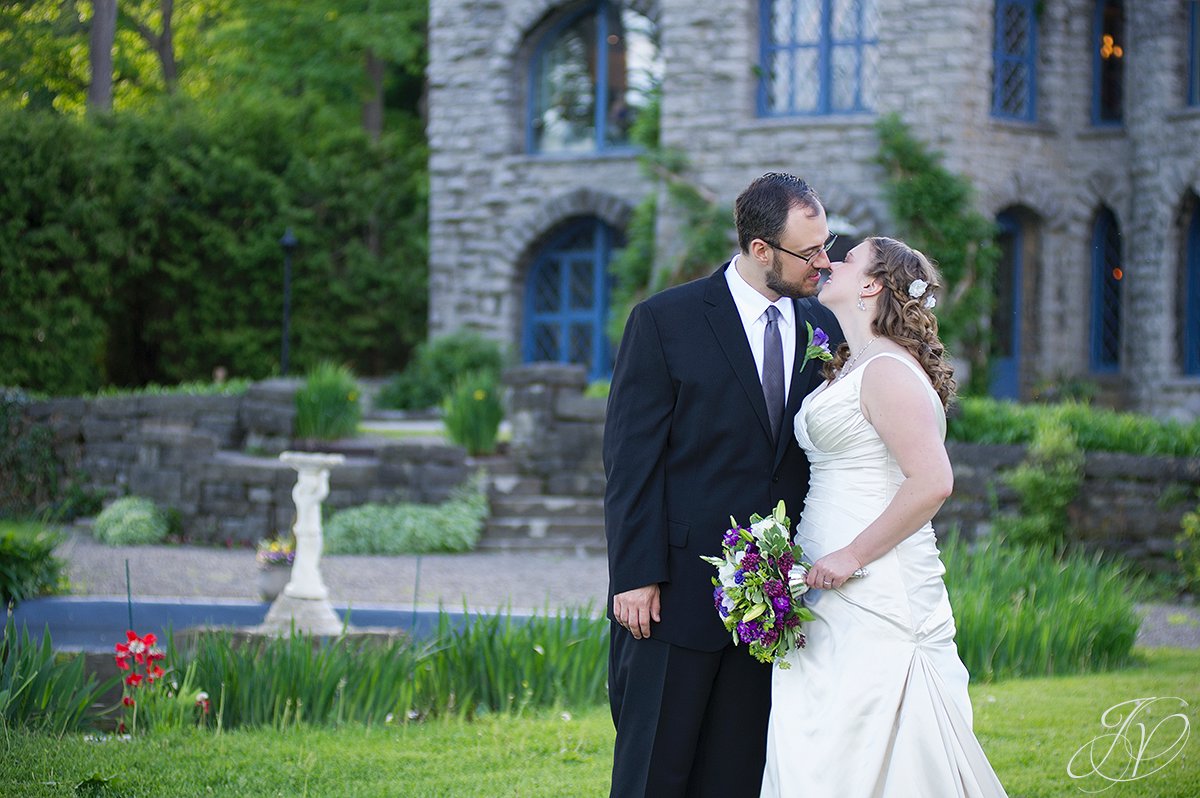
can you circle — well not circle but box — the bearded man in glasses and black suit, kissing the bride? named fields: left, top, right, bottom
left=604, top=173, right=842, bottom=798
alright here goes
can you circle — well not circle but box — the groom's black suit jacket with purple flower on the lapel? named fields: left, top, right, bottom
left=604, top=263, right=842, bottom=650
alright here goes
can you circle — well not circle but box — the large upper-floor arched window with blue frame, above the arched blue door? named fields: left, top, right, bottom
left=527, top=0, right=662, bottom=154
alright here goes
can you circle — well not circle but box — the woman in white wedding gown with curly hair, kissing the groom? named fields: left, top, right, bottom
left=762, top=238, right=1004, bottom=798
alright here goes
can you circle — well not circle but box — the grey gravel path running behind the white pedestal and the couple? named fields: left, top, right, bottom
left=51, top=533, right=1200, bottom=648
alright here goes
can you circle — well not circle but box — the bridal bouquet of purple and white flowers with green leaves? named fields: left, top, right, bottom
left=701, top=502, right=814, bottom=668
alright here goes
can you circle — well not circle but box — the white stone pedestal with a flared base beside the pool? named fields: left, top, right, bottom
left=258, top=451, right=346, bottom=635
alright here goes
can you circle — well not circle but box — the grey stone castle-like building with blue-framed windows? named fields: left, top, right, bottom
left=428, top=0, right=1200, bottom=419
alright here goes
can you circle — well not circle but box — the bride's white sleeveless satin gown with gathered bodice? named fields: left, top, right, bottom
left=762, top=353, right=1004, bottom=798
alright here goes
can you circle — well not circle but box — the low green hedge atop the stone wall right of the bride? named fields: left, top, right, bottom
left=947, top=397, right=1200, bottom=457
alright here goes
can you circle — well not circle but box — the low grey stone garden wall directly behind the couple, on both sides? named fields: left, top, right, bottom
left=505, top=364, right=1200, bottom=571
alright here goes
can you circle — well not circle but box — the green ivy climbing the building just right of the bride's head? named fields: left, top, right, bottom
left=876, top=114, right=1000, bottom=394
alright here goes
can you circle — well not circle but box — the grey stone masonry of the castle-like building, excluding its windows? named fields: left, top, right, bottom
left=428, top=0, right=1200, bottom=419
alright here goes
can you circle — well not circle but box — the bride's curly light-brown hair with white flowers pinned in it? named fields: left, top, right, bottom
left=824, top=236, right=958, bottom=408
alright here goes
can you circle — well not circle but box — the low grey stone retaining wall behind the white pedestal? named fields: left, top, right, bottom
left=29, top=380, right=468, bottom=544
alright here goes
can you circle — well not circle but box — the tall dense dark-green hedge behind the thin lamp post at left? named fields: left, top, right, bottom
left=0, top=98, right=427, bottom=394
